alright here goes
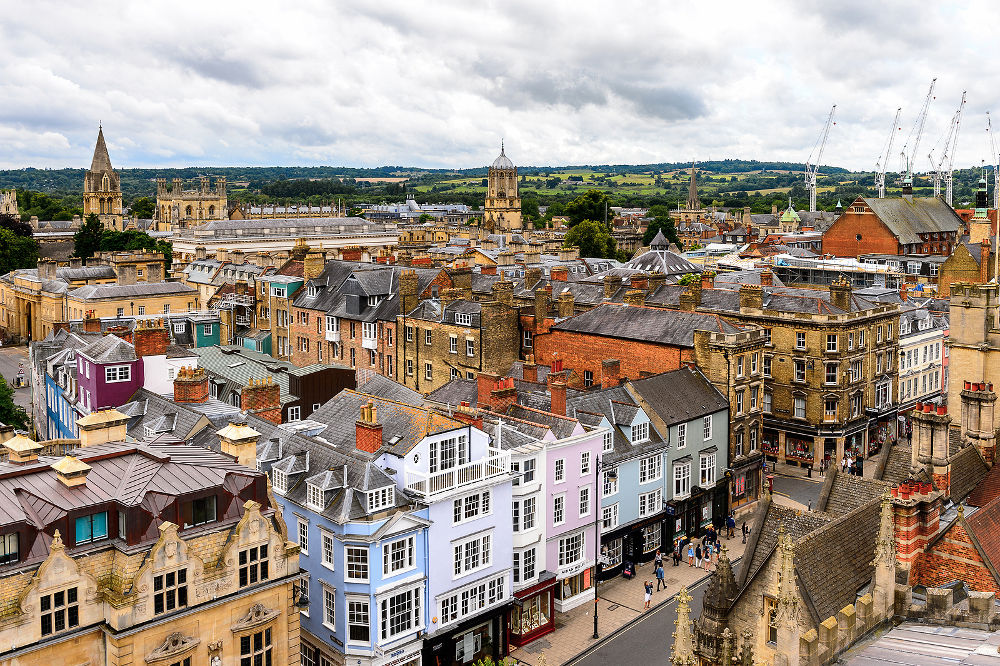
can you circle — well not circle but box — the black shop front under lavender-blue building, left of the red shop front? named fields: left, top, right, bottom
left=423, top=605, right=510, bottom=666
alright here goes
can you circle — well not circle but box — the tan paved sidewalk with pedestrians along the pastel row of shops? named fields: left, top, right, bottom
left=510, top=532, right=746, bottom=666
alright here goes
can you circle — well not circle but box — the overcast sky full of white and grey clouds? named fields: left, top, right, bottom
left=0, top=0, right=1000, bottom=169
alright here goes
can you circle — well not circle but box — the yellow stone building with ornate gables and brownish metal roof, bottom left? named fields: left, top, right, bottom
left=0, top=410, right=299, bottom=666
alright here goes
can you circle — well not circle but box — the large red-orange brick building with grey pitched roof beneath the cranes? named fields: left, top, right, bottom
left=823, top=196, right=962, bottom=257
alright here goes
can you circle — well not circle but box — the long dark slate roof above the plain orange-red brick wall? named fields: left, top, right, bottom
left=552, top=303, right=739, bottom=347
